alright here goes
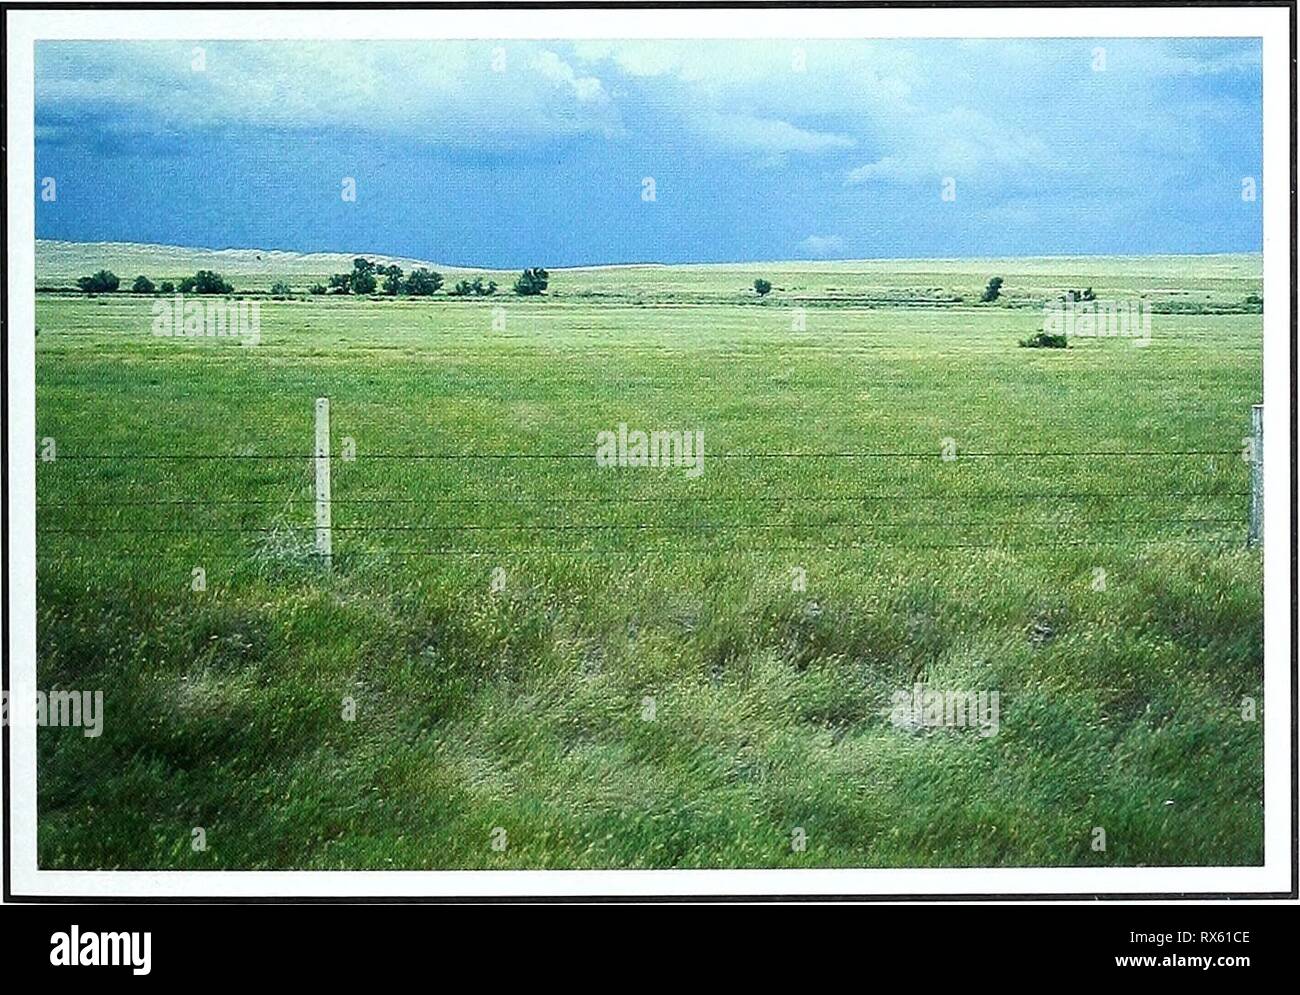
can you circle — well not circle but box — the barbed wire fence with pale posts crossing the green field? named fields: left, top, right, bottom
left=36, top=398, right=1264, bottom=567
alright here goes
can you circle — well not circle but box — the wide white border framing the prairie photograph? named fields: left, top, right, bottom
left=0, top=3, right=1300, bottom=901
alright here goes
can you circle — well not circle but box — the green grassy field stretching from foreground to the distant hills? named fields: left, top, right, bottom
left=36, top=246, right=1264, bottom=869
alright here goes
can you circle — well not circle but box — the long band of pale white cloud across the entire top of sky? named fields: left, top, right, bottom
left=36, top=39, right=1258, bottom=186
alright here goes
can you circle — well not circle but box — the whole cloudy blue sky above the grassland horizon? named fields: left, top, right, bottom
left=36, top=39, right=1265, bottom=268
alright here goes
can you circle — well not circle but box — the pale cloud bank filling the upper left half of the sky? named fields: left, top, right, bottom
left=36, top=40, right=618, bottom=146
